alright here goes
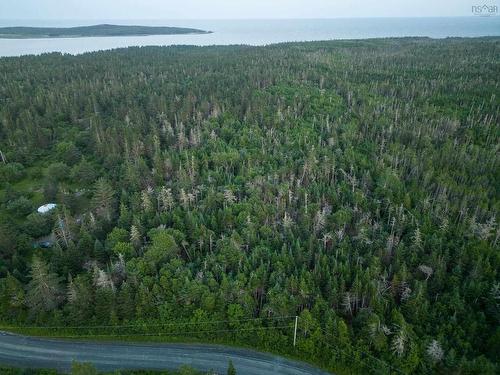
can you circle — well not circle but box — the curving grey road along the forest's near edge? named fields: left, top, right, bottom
left=0, top=333, right=327, bottom=375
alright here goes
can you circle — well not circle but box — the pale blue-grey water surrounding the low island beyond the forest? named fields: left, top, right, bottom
left=0, top=16, right=500, bottom=56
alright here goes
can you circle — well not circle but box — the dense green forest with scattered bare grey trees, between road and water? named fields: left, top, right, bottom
left=0, top=38, right=500, bottom=374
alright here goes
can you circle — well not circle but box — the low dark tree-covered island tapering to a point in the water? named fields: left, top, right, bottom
left=0, top=24, right=211, bottom=39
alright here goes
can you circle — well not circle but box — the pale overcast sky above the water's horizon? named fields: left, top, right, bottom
left=0, top=0, right=492, bottom=19
